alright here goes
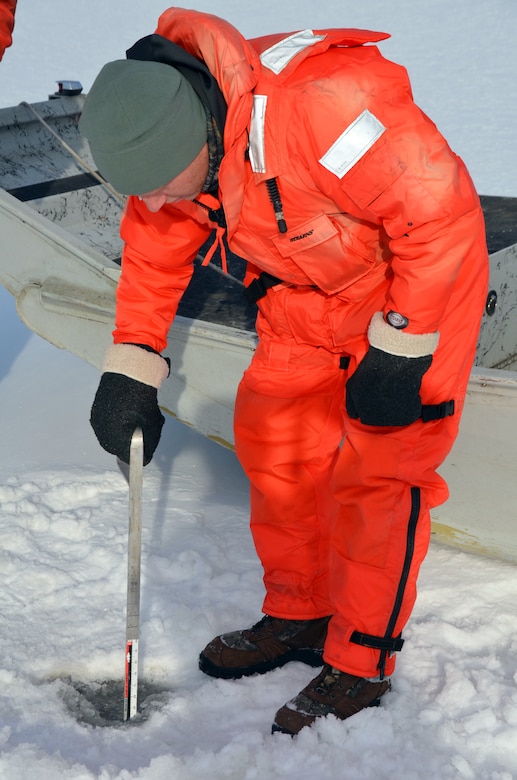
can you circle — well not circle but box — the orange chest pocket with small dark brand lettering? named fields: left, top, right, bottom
left=271, top=213, right=376, bottom=295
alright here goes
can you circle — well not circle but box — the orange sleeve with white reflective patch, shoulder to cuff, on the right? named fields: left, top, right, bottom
left=298, top=47, right=487, bottom=333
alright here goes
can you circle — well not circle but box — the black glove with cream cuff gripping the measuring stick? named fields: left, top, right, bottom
left=90, top=344, right=169, bottom=466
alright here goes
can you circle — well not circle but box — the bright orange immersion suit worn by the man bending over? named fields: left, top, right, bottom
left=114, top=8, right=488, bottom=677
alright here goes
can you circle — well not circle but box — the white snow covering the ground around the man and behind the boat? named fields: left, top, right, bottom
left=0, top=0, right=517, bottom=780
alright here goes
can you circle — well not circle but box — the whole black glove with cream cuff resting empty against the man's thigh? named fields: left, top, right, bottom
left=346, top=312, right=439, bottom=426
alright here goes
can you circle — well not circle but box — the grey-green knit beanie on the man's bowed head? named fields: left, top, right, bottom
left=79, top=60, right=207, bottom=195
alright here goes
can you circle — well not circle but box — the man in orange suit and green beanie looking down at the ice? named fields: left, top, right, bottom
left=80, top=8, right=488, bottom=734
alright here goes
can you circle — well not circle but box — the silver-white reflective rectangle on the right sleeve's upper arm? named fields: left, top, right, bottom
left=319, top=109, right=386, bottom=179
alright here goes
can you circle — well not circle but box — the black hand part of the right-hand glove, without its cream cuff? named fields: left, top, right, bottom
left=346, top=346, right=433, bottom=425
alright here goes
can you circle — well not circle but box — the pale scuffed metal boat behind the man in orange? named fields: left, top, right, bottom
left=0, top=96, right=517, bottom=561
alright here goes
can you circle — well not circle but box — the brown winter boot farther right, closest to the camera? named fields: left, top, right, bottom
left=272, top=664, right=390, bottom=736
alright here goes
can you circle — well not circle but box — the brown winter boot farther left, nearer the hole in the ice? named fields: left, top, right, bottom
left=199, top=615, right=330, bottom=679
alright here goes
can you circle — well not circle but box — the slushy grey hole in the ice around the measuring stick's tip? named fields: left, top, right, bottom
left=59, top=677, right=170, bottom=727
